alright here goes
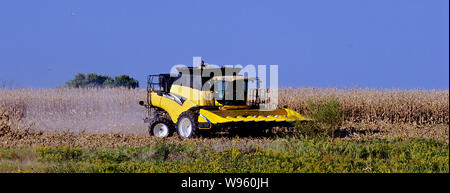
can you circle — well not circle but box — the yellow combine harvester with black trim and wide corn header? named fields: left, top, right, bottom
left=139, top=63, right=308, bottom=138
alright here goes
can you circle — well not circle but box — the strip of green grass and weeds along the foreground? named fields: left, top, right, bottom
left=0, top=137, right=449, bottom=173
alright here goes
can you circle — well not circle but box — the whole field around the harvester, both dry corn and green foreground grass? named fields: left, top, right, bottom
left=0, top=88, right=449, bottom=172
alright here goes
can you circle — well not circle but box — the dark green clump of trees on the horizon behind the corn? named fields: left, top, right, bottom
left=65, top=73, right=139, bottom=88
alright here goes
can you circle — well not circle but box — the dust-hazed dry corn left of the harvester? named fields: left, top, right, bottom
left=0, top=89, right=146, bottom=133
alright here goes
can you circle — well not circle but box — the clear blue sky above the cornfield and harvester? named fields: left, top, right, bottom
left=0, top=0, right=449, bottom=89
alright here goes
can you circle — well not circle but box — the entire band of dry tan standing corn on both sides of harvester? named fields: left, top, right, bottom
left=0, top=88, right=449, bottom=134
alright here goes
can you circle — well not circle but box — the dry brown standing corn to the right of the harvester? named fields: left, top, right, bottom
left=278, top=88, right=449, bottom=124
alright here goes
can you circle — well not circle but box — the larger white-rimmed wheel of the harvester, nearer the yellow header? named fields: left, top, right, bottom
left=177, top=111, right=198, bottom=138
